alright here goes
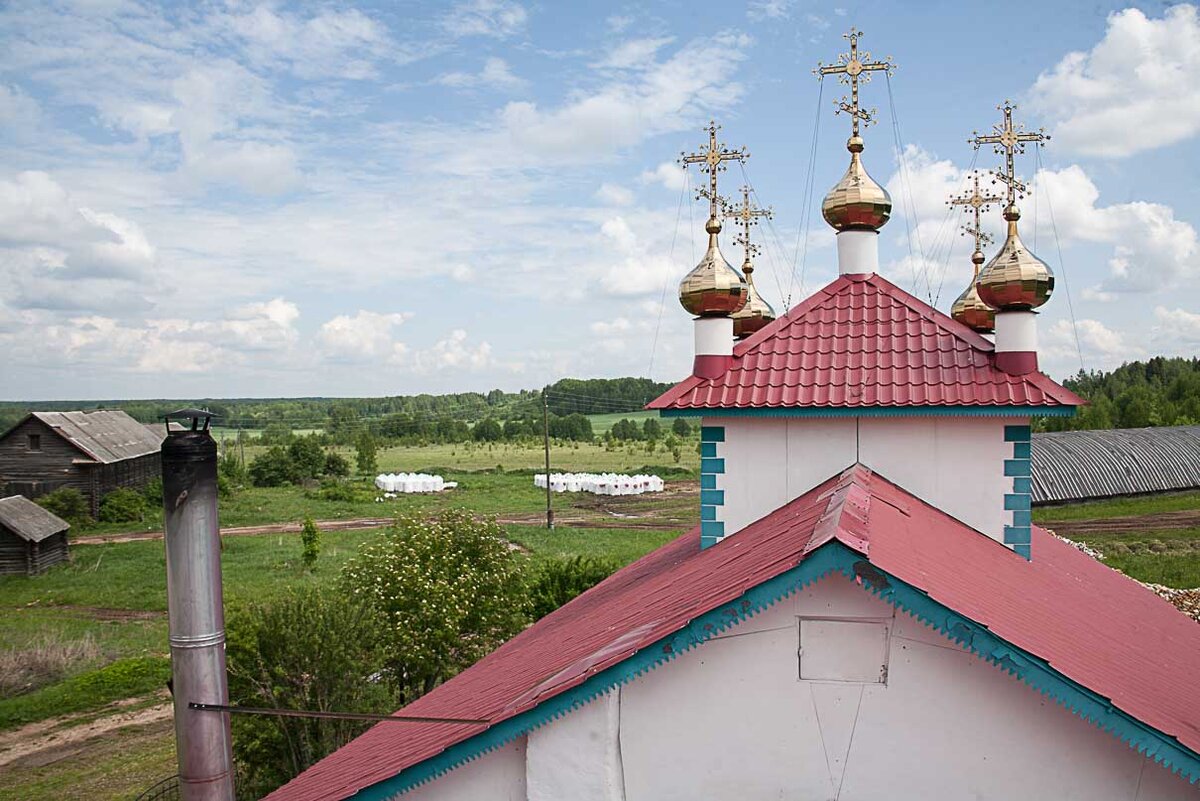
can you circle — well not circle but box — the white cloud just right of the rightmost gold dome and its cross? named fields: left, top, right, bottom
left=1034, top=165, right=1200, bottom=297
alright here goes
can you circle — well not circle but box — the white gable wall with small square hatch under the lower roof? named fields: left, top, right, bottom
left=406, top=577, right=1198, bottom=801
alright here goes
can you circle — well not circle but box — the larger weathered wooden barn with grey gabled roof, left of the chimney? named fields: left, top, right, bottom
left=0, top=411, right=166, bottom=517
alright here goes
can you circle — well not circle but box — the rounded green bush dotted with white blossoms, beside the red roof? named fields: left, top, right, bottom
left=341, top=510, right=524, bottom=701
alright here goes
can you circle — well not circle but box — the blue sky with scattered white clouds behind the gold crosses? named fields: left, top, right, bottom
left=0, top=0, right=1200, bottom=399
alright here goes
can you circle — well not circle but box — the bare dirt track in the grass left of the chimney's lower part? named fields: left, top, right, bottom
left=0, top=695, right=172, bottom=775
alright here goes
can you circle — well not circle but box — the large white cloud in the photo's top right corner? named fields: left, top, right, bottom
left=1030, top=5, right=1200, bottom=158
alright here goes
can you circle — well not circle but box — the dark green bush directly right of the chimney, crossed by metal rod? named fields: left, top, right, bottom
left=226, top=588, right=400, bottom=799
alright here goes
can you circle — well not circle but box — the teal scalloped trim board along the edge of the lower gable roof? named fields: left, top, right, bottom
left=350, top=541, right=1200, bottom=801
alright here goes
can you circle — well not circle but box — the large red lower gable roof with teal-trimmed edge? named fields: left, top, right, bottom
left=268, top=465, right=1200, bottom=801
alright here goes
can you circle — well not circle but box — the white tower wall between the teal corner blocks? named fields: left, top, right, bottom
left=704, top=417, right=1028, bottom=542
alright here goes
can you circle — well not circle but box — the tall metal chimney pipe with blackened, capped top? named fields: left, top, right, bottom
left=162, top=409, right=234, bottom=801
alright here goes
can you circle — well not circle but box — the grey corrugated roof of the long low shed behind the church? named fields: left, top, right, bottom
left=1031, top=426, right=1200, bottom=504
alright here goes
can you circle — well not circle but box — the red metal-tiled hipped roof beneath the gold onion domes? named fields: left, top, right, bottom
left=647, top=275, right=1085, bottom=410
